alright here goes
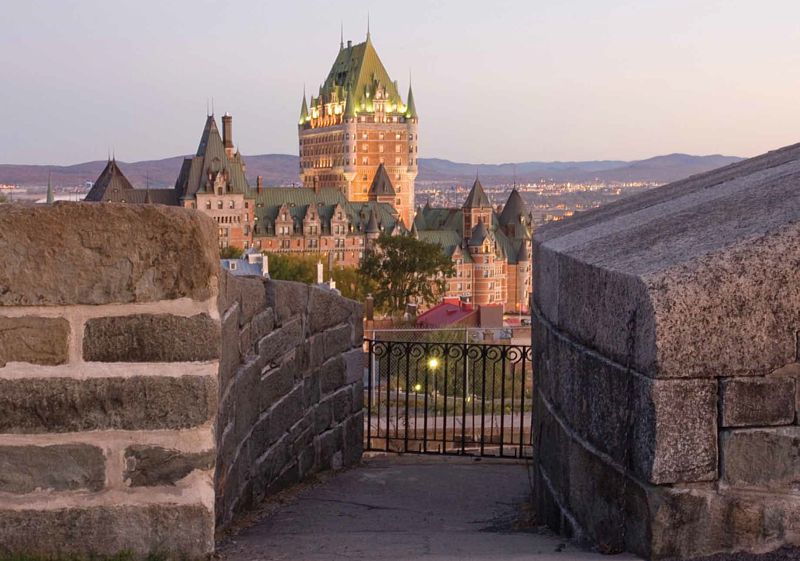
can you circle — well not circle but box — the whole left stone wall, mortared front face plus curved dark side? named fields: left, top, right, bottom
left=0, top=203, right=363, bottom=559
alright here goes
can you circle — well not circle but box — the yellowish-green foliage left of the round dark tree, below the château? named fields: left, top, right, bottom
left=267, top=253, right=365, bottom=301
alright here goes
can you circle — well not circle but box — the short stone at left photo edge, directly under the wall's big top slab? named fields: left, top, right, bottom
left=0, top=316, right=70, bottom=367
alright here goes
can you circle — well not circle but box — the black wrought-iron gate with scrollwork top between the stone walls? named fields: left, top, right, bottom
left=365, top=340, right=533, bottom=458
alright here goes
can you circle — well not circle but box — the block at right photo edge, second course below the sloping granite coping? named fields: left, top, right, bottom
left=720, top=426, right=800, bottom=493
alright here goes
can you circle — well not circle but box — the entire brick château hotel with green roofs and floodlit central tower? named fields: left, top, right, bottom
left=86, top=33, right=531, bottom=313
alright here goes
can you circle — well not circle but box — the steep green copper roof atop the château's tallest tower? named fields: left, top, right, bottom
left=320, top=37, right=403, bottom=111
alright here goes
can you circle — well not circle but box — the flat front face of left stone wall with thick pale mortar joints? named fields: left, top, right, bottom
left=0, top=204, right=221, bottom=557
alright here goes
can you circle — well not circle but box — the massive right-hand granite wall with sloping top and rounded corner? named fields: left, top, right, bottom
left=533, top=145, right=800, bottom=559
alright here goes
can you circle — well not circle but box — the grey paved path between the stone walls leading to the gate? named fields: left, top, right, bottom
left=219, top=456, right=635, bottom=561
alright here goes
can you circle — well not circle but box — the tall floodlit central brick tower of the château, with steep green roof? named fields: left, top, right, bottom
left=298, top=32, right=419, bottom=225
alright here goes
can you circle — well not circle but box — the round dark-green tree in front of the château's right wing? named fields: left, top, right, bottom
left=359, top=233, right=455, bottom=314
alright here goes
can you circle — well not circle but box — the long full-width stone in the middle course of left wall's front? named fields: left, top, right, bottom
left=0, top=376, right=217, bottom=434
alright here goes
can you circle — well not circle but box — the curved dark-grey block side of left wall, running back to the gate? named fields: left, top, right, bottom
left=216, top=273, right=364, bottom=528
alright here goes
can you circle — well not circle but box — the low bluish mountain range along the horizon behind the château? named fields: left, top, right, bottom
left=0, top=154, right=742, bottom=188
